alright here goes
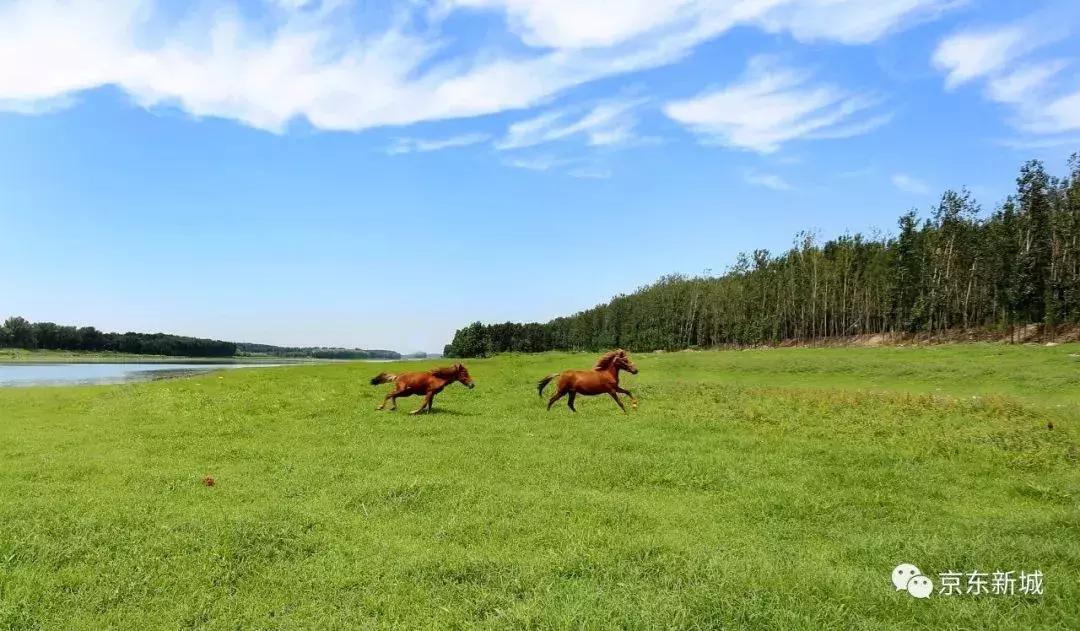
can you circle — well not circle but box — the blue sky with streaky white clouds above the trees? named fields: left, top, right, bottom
left=0, top=0, right=1080, bottom=351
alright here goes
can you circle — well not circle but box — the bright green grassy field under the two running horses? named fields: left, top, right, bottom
left=0, top=345, right=1080, bottom=630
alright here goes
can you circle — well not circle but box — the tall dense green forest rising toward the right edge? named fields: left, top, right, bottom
left=445, top=153, right=1080, bottom=357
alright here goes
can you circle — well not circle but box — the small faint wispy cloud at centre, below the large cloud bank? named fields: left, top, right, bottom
left=496, top=100, right=643, bottom=149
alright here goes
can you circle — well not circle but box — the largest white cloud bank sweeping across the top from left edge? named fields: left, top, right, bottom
left=0, top=0, right=946, bottom=131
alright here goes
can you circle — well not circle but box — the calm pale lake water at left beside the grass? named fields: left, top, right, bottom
left=0, top=363, right=285, bottom=387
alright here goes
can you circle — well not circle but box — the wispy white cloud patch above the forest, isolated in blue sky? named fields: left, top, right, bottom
left=664, top=57, right=890, bottom=153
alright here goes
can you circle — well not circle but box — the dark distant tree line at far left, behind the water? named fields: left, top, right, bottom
left=0, top=316, right=237, bottom=358
